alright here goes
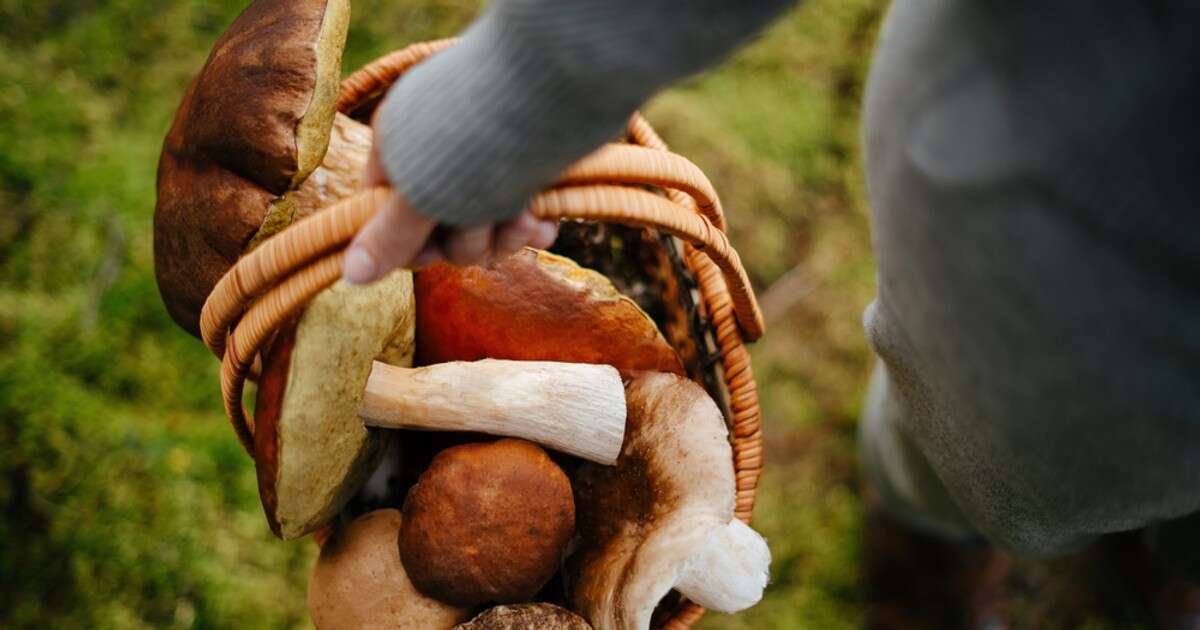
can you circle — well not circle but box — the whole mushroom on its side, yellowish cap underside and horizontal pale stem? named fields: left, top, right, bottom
left=254, top=309, right=625, bottom=539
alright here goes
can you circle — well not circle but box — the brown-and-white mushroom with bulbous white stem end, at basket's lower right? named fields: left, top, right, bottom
left=565, top=373, right=770, bottom=630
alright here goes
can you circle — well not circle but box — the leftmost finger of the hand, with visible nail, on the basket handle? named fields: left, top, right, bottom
left=342, top=194, right=434, bottom=284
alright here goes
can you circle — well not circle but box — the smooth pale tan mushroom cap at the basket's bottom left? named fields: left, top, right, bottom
left=308, top=510, right=470, bottom=630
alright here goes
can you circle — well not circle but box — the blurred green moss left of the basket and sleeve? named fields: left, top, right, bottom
left=0, top=0, right=475, bottom=628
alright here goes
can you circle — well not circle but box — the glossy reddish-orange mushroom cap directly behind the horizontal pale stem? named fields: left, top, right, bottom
left=414, top=248, right=684, bottom=374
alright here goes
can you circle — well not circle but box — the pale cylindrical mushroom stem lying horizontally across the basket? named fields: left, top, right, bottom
left=359, top=359, right=625, bottom=466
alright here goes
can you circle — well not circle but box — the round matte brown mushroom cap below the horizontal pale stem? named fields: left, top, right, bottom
left=400, top=439, right=575, bottom=606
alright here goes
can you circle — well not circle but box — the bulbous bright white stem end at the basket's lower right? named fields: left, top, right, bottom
left=676, top=520, right=770, bottom=612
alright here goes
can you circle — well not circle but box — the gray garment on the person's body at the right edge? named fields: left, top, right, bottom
left=864, top=0, right=1200, bottom=553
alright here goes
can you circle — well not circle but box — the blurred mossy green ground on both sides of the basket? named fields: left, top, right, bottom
left=0, top=0, right=1156, bottom=629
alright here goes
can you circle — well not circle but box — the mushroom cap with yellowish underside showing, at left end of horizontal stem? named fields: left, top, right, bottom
left=254, top=271, right=414, bottom=540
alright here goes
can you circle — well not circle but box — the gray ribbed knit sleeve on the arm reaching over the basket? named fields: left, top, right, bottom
left=376, top=0, right=793, bottom=224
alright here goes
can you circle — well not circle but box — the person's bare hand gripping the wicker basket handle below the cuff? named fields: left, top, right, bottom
left=342, top=114, right=558, bottom=284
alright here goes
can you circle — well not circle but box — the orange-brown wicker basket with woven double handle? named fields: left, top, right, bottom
left=193, top=40, right=763, bottom=629
